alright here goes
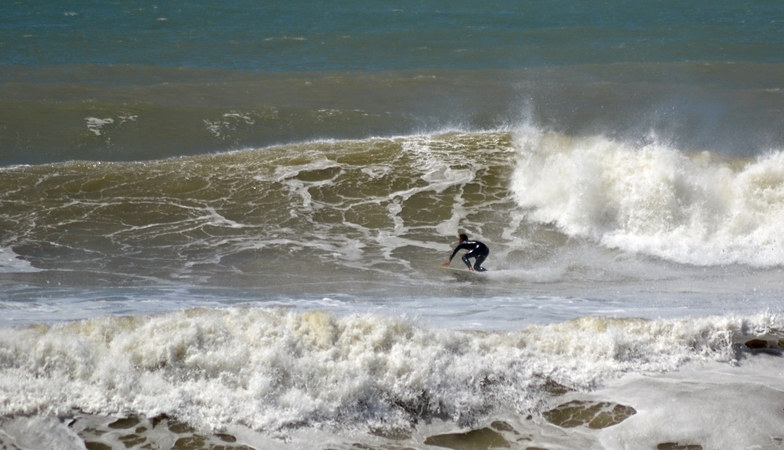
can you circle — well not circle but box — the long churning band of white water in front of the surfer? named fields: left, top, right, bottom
left=0, top=308, right=772, bottom=432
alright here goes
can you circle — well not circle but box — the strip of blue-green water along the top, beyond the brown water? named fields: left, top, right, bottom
left=0, top=0, right=784, bottom=72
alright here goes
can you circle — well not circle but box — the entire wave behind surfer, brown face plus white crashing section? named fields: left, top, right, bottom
left=0, top=128, right=784, bottom=296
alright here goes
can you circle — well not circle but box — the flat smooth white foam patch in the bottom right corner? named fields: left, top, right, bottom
left=592, top=355, right=784, bottom=449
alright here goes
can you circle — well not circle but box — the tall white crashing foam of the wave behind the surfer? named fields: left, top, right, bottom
left=511, top=129, right=784, bottom=267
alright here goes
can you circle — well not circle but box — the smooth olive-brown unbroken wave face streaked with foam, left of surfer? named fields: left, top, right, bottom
left=0, top=133, right=514, bottom=290
